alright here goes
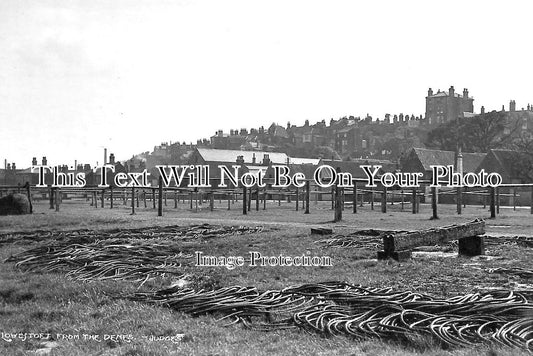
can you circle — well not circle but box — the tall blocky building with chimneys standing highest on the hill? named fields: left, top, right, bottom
left=426, top=86, right=474, bottom=125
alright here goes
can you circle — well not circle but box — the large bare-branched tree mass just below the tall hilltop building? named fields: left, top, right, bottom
left=426, top=111, right=519, bottom=152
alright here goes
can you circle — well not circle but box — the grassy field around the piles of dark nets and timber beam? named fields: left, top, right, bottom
left=0, top=201, right=533, bottom=355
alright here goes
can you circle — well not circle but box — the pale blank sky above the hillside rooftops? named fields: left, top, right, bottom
left=0, top=0, right=533, bottom=168
